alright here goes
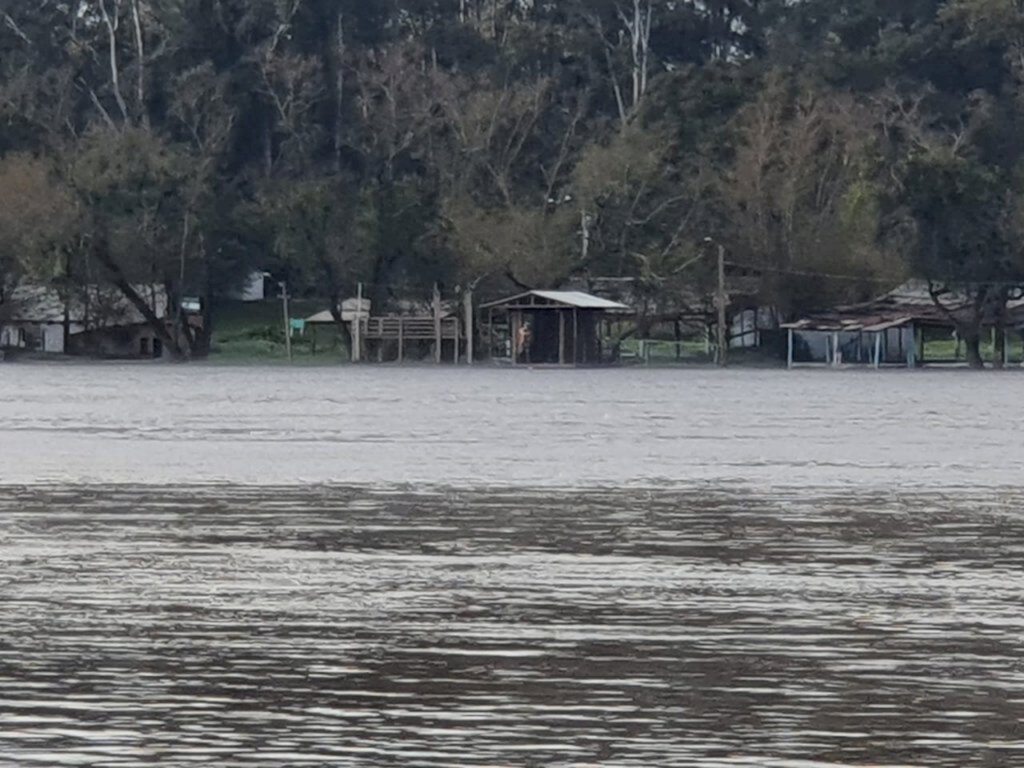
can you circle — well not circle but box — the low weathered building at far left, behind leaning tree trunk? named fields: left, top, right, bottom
left=0, top=285, right=174, bottom=358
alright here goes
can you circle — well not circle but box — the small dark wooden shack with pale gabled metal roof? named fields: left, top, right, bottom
left=480, top=291, right=631, bottom=366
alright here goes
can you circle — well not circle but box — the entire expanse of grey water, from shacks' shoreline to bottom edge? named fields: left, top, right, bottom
left=0, top=365, right=1024, bottom=768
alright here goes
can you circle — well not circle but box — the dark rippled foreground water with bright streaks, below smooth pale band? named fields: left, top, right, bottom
left=0, top=485, right=1024, bottom=768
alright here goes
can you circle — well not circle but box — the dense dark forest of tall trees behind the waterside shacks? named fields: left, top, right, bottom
left=0, top=0, right=1024, bottom=364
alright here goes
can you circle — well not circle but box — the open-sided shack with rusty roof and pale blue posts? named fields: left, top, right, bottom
left=782, top=281, right=1024, bottom=368
